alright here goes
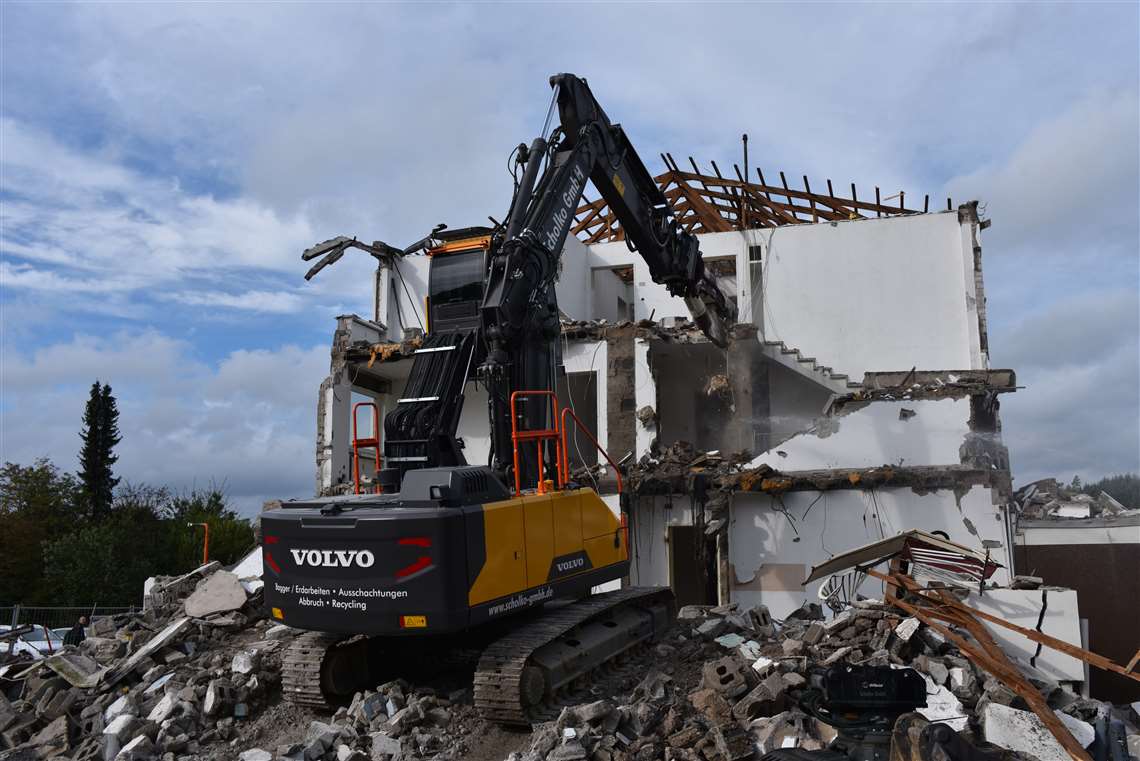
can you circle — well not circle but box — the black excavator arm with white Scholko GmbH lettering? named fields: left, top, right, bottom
left=480, top=74, right=735, bottom=483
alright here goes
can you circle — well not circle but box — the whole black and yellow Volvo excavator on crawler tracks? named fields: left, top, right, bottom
left=261, top=74, right=735, bottom=725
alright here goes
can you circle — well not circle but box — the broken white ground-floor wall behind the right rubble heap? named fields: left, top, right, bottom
left=725, top=486, right=1010, bottom=617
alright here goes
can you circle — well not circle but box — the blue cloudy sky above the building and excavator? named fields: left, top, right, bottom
left=0, top=0, right=1140, bottom=513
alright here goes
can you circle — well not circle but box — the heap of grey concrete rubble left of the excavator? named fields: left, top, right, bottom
left=0, top=563, right=293, bottom=761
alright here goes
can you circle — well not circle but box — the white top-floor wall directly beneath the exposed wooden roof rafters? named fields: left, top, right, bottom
left=591, top=212, right=985, bottom=379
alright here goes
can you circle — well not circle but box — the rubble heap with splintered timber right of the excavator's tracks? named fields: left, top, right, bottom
left=512, top=600, right=1140, bottom=761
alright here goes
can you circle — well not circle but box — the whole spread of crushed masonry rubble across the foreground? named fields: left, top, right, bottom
left=0, top=535, right=1140, bottom=761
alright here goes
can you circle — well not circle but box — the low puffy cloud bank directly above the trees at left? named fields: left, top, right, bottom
left=0, top=332, right=328, bottom=509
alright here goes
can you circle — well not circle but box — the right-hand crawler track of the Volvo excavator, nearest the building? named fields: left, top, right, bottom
left=474, top=588, right=673, bottom=726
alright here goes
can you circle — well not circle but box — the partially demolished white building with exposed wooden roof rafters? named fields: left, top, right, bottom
left=317, top=156, right=1016, bottom=617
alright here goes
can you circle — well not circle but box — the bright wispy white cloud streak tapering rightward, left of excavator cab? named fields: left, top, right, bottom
left=0, top=118, right=315, bottom=292
